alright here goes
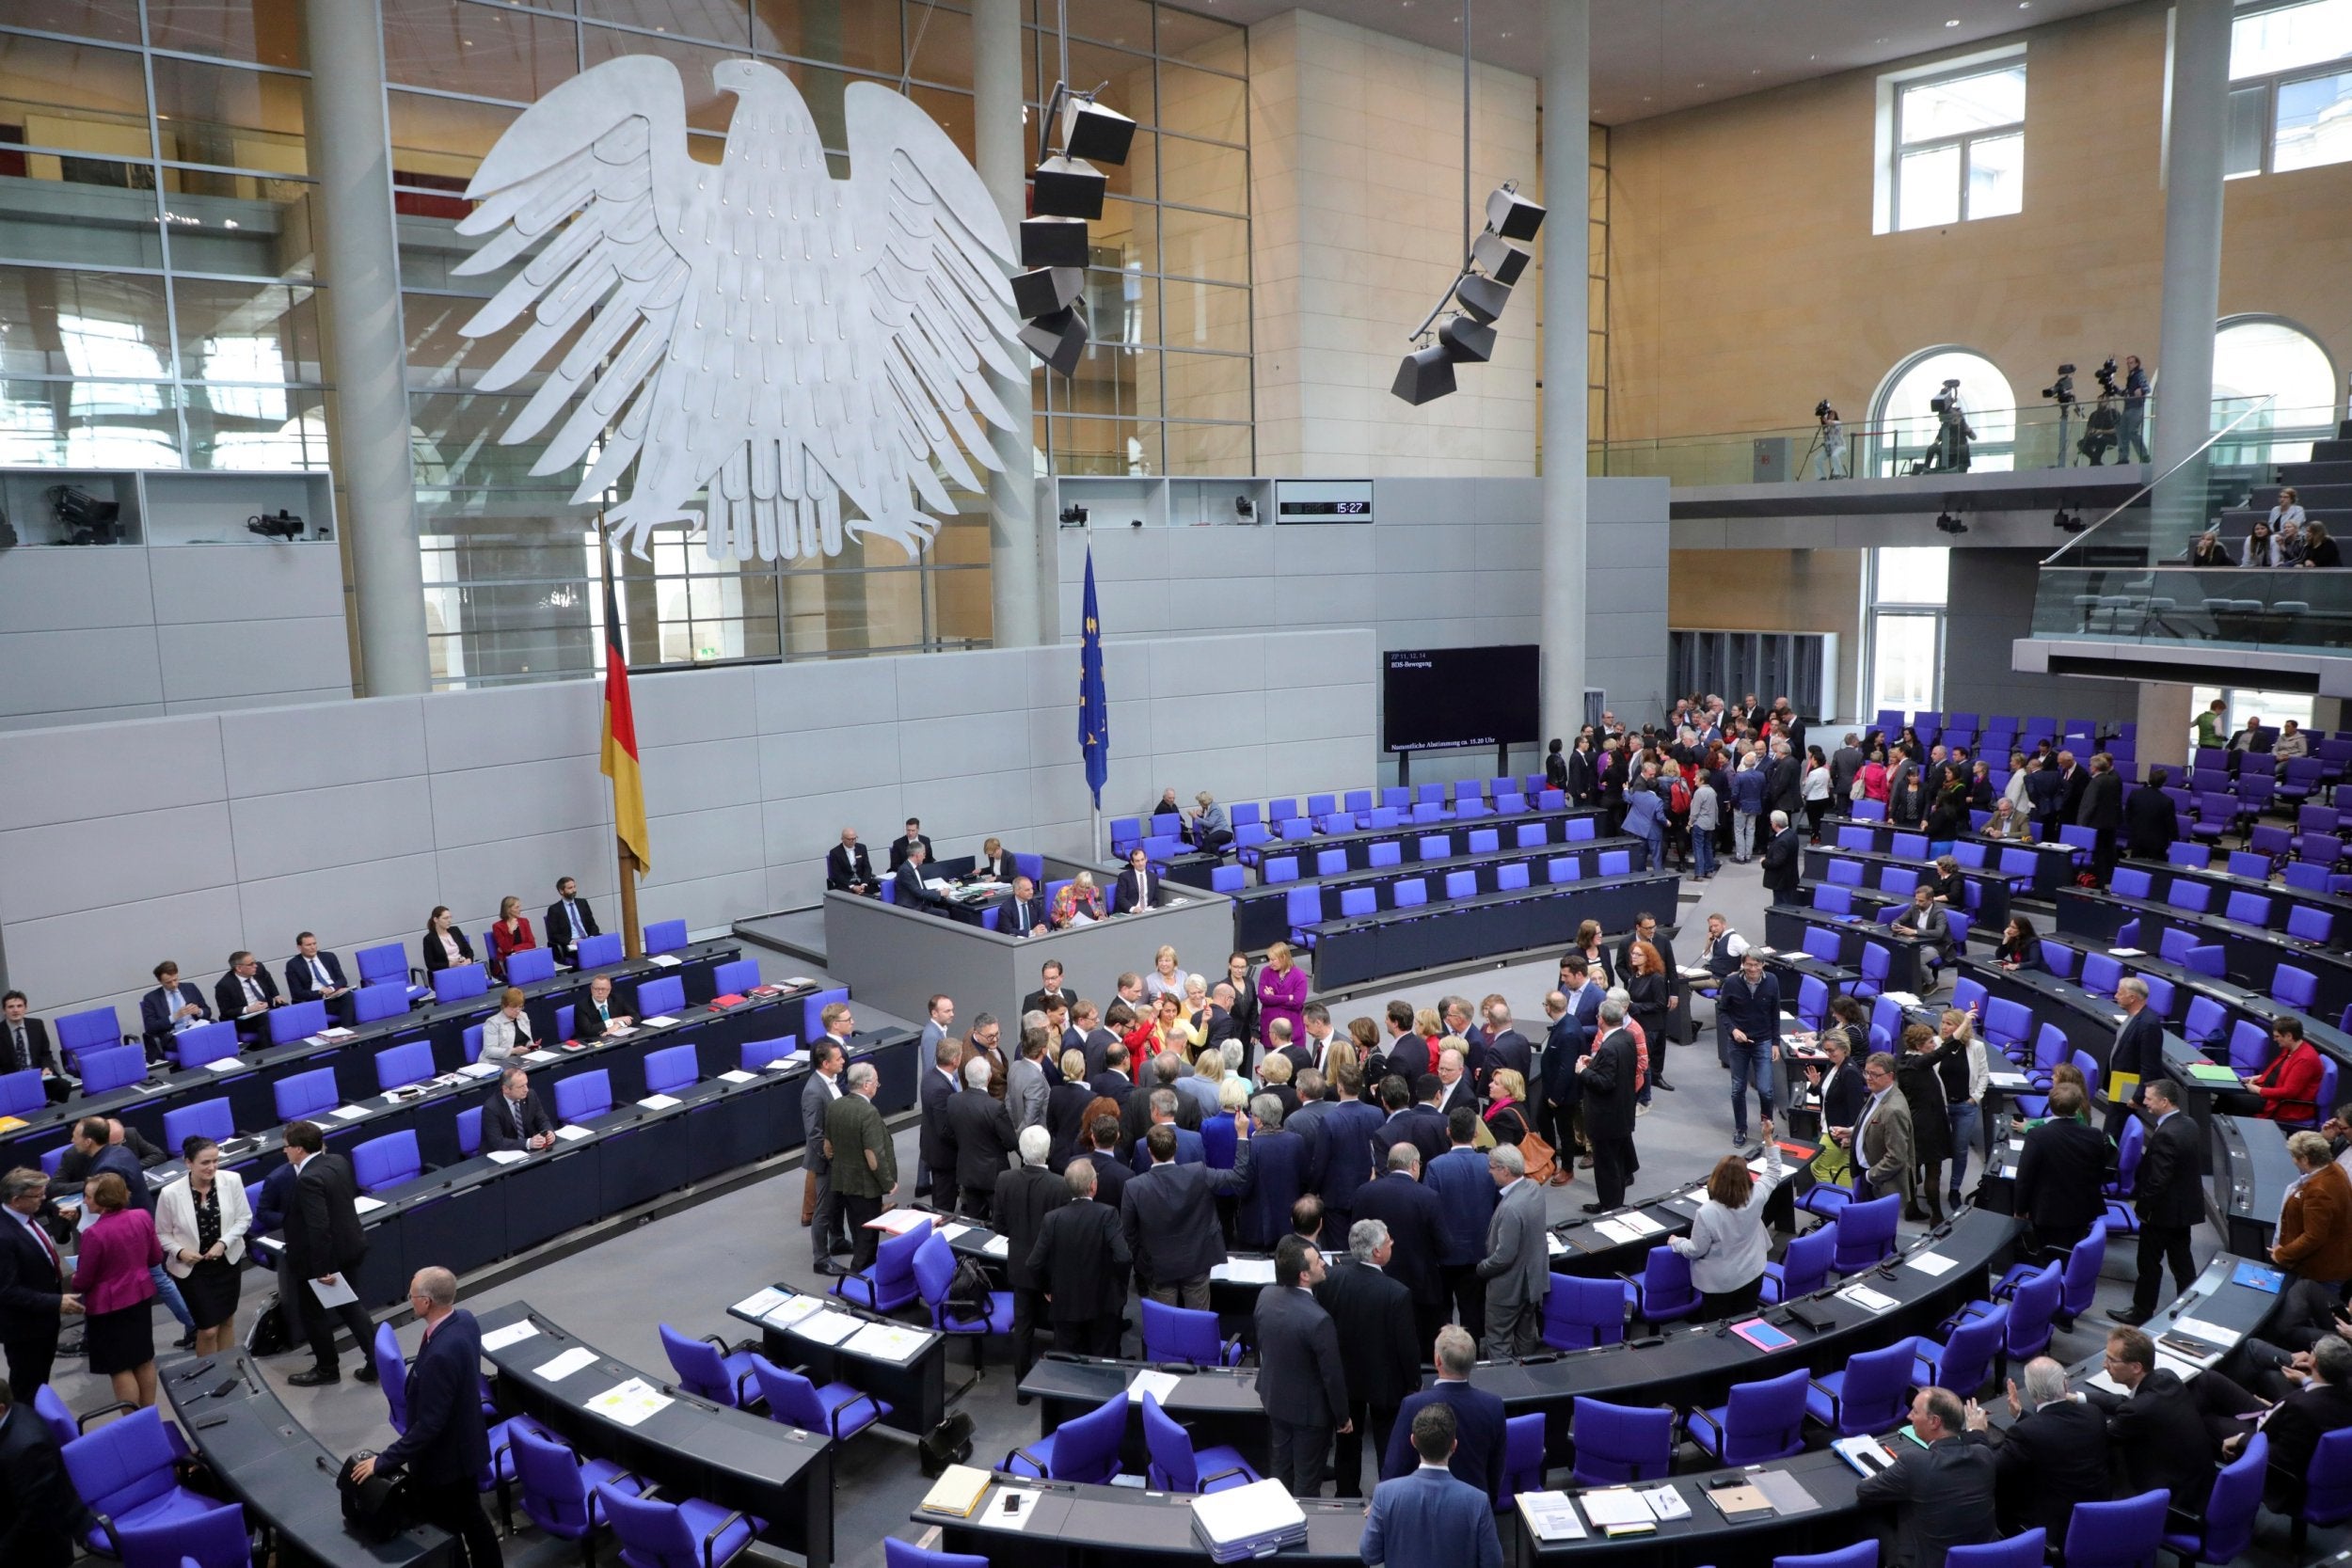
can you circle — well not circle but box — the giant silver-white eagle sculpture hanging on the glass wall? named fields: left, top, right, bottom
left=459, top=54, right=1028, bottom=560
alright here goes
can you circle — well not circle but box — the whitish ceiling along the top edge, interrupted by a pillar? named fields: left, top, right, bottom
left=1179, top=0, right=2131, bottom=124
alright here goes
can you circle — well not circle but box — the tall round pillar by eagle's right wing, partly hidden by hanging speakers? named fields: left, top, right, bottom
left=972, top=0, right=1044, bottom=649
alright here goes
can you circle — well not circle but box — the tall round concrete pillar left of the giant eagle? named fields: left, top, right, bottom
left=301, top=0, right=433, bottom=696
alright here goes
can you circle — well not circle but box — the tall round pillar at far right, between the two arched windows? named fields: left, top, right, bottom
left=2150, top=0, right=2230, bottom=560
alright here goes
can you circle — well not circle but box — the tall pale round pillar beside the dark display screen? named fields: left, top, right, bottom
left=1543, top=0, right=1593, bottom=738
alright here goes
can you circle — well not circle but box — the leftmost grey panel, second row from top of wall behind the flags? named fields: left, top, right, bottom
left=0, top=801, right=238, bottom=922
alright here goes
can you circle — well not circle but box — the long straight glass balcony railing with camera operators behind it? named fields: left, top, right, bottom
left=1588, top=397, right=2336, bottom=484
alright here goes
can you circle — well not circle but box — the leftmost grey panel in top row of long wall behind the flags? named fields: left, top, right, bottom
left=0, top=717, right=229, bottom=830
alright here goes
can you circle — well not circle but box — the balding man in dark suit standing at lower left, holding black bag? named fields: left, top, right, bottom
left=351, top=1270, right=506, bottom=1568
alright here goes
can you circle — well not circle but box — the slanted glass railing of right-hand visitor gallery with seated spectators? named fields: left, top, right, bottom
left=2035, top=397, right=2352, bottom=656
